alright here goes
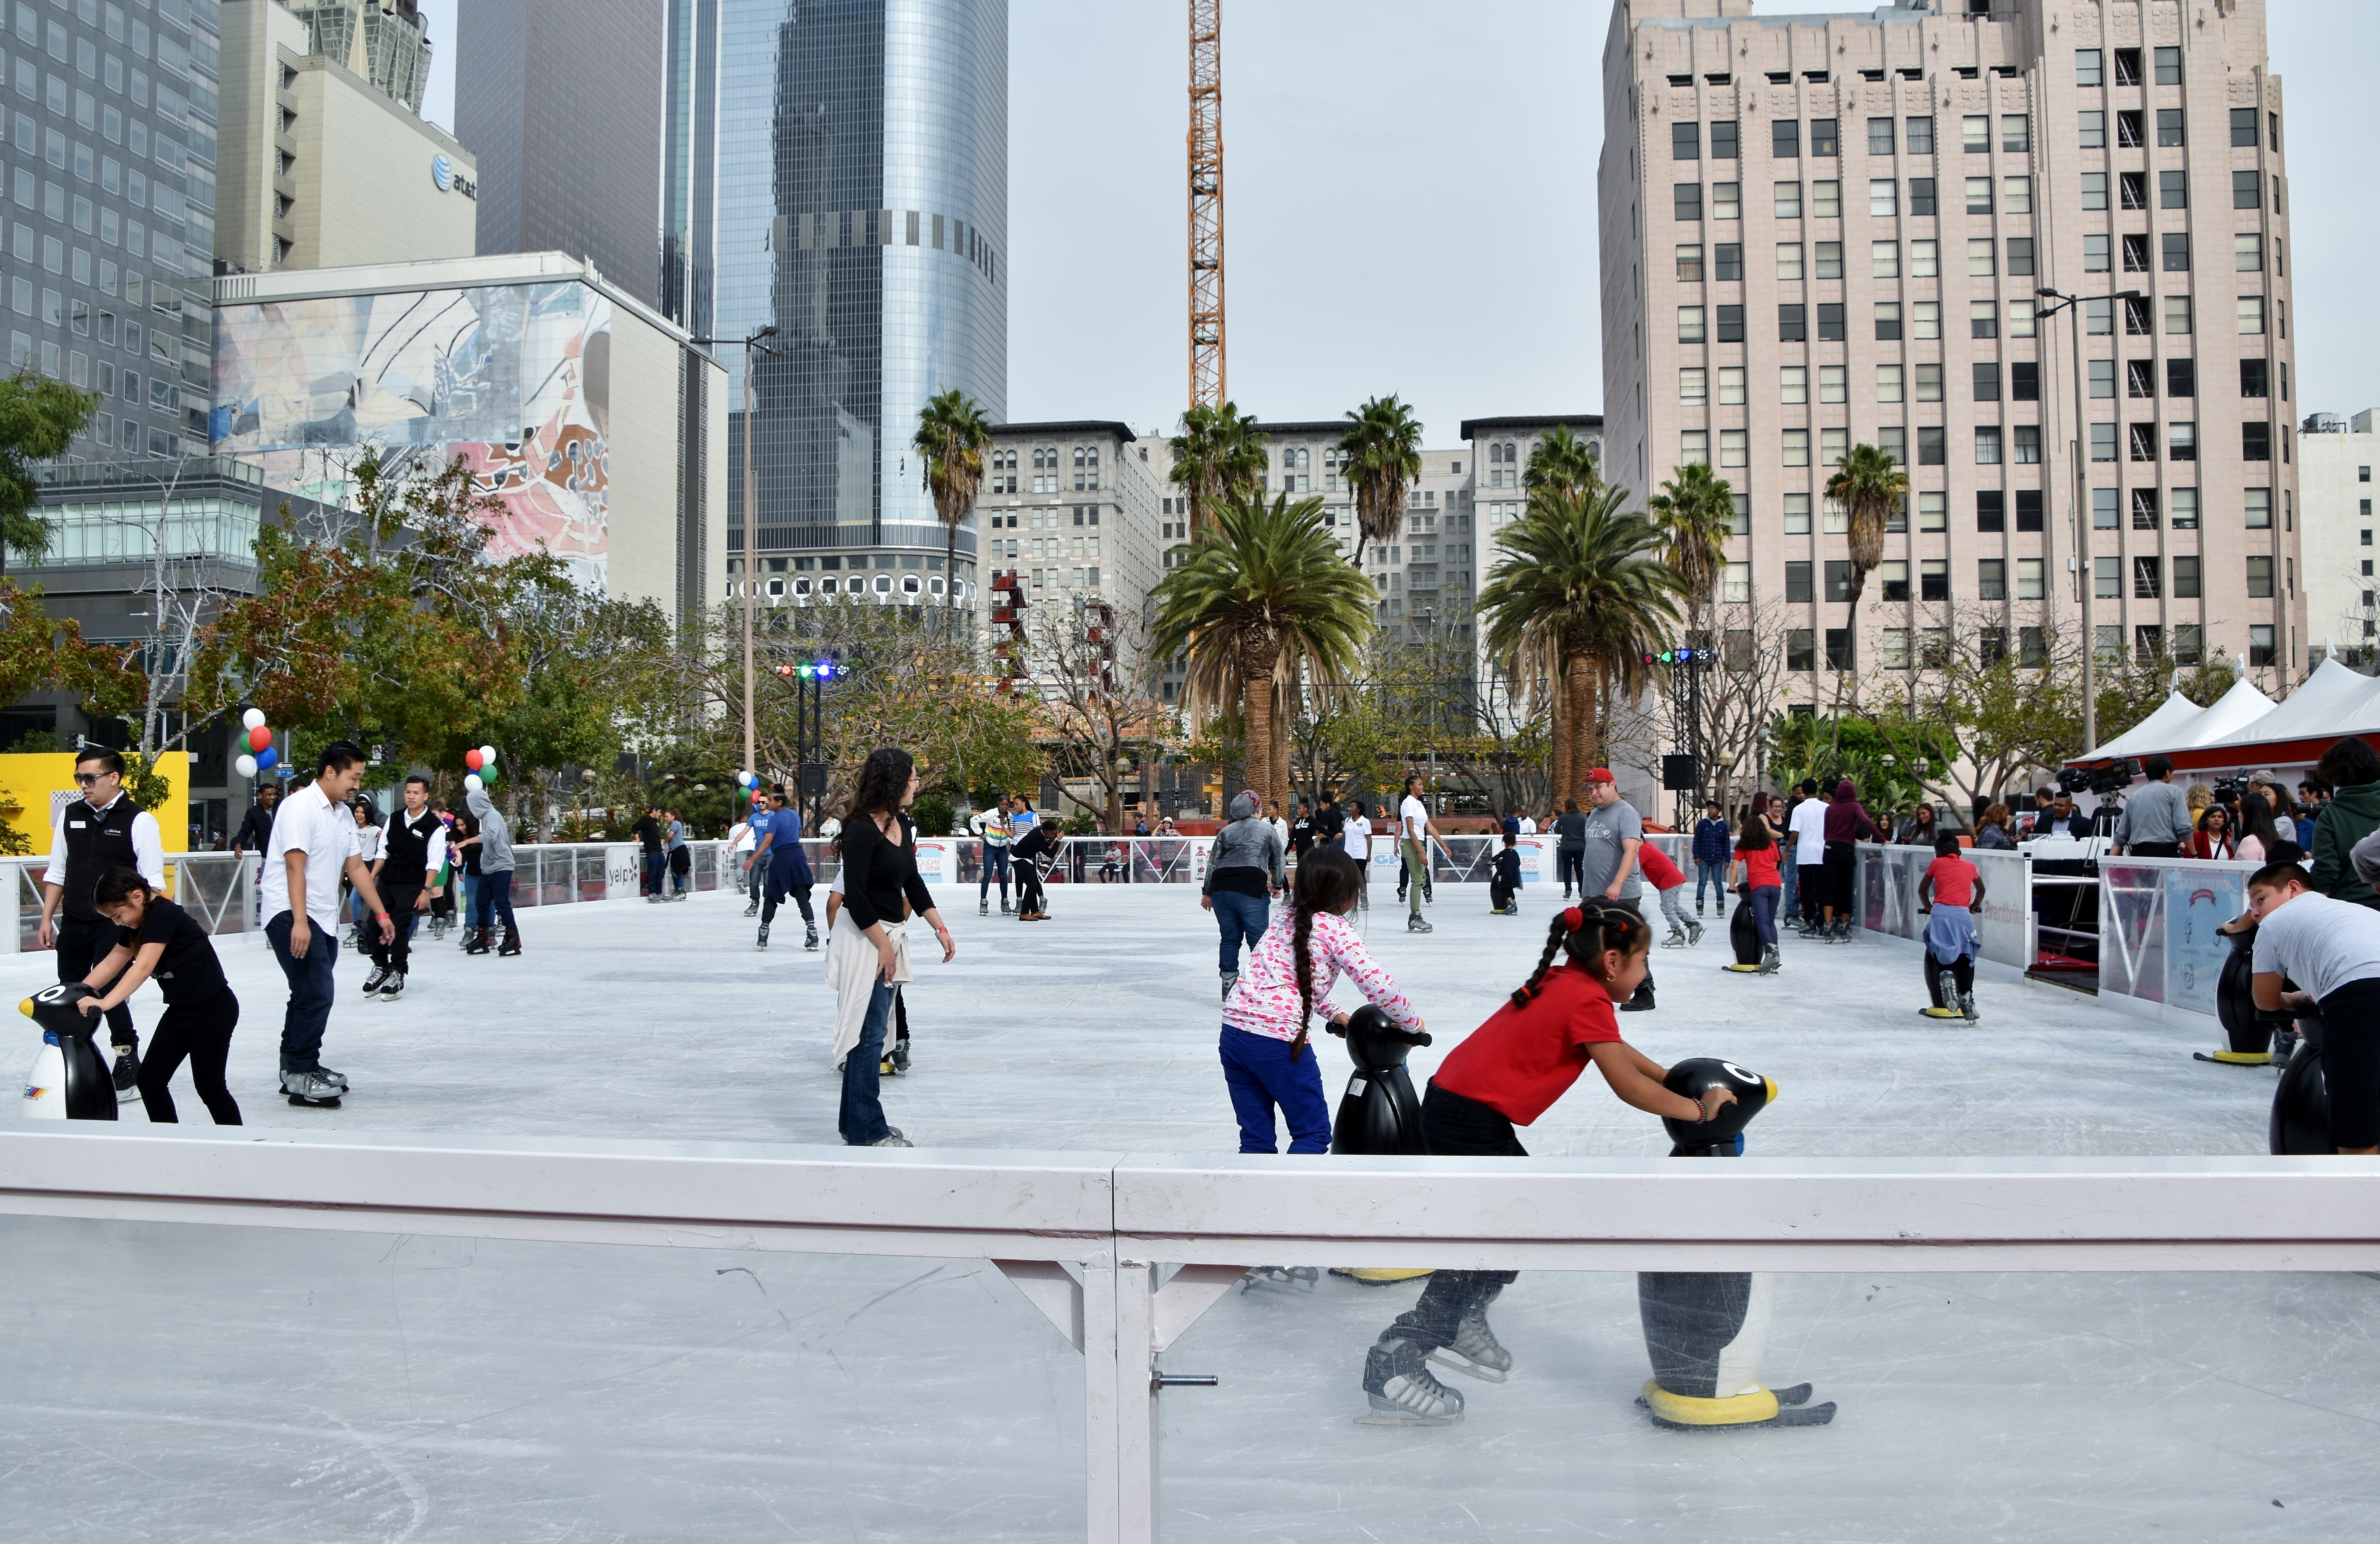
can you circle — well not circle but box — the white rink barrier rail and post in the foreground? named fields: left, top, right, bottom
left=0, top=1125, right=2380, bottom=1544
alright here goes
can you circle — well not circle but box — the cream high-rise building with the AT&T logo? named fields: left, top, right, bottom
left=214, top=0, right=478, bottom=274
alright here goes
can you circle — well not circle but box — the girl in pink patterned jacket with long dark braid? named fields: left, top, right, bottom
left=1221, top=847, right=1421, bottom=1151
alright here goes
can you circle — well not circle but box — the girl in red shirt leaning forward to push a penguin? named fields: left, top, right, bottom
left=1361, top=902, right=1735, bottom=1425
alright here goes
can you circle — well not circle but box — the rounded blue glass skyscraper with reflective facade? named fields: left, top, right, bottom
left=662, top=0, right=1009, bottom=597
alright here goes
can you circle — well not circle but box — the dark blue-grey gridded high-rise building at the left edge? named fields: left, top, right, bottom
left=0, top=0, right=219, bottom=459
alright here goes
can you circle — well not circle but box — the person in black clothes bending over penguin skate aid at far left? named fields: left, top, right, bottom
left=76, top=868, right=240, bottom=1125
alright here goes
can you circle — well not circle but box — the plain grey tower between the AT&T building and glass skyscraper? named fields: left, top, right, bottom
left=455, top=0, right=664, bottom=307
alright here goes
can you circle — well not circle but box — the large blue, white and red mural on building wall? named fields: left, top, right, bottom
left=209, top=283, right=612, bottom=590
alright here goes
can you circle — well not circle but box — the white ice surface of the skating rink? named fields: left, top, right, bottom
left=0, top=885, right=2380, bottom=1544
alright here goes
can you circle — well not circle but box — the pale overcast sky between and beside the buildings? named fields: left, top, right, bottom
left=421, top=0, right=2380, bottom=445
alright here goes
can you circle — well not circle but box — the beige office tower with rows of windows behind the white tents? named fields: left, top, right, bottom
left=1599, top=0, right=2309, bottom=738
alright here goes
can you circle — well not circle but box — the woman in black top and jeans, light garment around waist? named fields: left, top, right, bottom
left=835, top=747, right=959, bottom=1147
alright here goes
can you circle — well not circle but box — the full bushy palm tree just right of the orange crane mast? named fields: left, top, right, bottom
left=1150, top=492, right=1371, bottom=809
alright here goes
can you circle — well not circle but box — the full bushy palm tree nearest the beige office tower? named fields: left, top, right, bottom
left=1478, top=483, right=1685, bottom=800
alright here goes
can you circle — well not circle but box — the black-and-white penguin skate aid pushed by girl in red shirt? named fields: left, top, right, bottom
left=1637, top=1056, right=1835, bottom=1430
